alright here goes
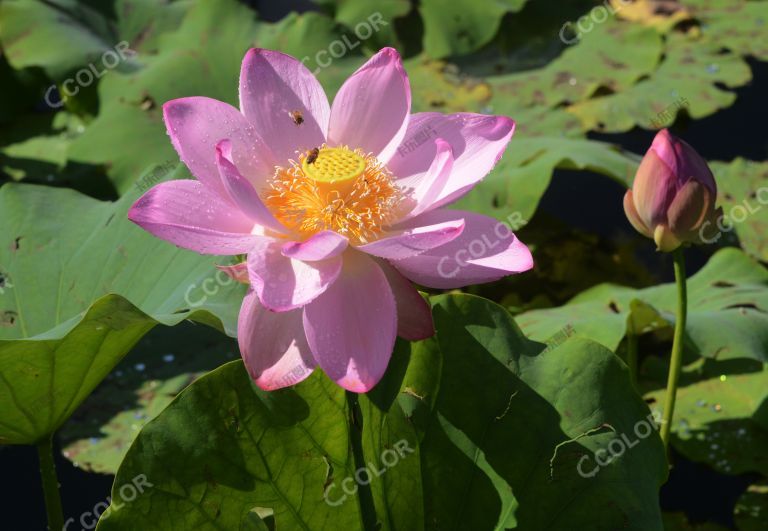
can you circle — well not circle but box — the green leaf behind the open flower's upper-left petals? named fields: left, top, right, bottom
left=64, top=0, right=359, bottom=194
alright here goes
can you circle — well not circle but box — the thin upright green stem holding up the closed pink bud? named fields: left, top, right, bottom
left=661, top=247, right=688, bottom=449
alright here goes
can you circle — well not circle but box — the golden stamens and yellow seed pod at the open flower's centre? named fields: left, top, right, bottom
left=264, top=146, right=403, bottom=244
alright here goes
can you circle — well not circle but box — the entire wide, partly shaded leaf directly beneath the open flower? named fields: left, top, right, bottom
left=99, top=295, right=666, bottom=530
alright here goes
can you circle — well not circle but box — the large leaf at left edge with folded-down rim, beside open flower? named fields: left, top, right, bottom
left=0, top=180, right=243, bottom=443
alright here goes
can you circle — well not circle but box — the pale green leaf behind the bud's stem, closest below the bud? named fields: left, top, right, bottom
left=518, top=248, right=768, bottom=361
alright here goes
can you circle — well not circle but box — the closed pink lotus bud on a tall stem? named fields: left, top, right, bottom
left=624, top=129, right=722, bottom=252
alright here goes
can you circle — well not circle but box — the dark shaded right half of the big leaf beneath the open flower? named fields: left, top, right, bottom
left=421, top=296, right=666, bottom=529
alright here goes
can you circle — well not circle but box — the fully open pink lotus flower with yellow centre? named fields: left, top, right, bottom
left=128, top=48, right=533, bottom=392
